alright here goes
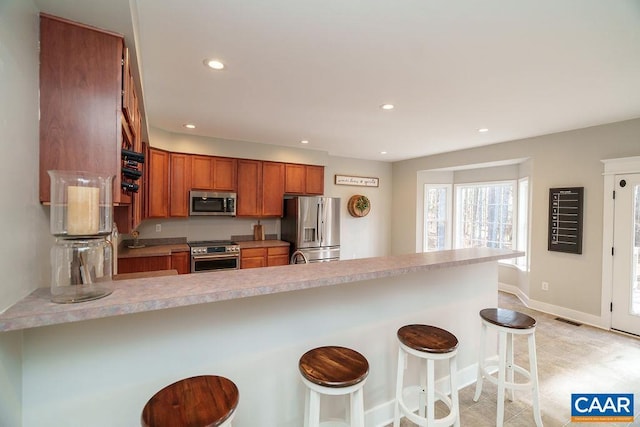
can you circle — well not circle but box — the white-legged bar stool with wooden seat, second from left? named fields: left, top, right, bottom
left=298, top=346, right=369, bottom=427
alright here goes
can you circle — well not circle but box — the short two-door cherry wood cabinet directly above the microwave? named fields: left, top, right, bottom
left=191, top=155, right=238, bottom=191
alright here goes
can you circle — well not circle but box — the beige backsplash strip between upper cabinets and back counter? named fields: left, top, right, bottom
left=132, top=217, right=280, bottom=241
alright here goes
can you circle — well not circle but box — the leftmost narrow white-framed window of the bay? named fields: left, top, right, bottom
left=422, top=184, right=452, bottom=252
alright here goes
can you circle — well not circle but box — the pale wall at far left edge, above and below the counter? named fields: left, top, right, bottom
left=0, top=0, right=43, bottom=426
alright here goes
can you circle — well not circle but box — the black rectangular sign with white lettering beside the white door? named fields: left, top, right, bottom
left=547, top=187, right=584, bottom=254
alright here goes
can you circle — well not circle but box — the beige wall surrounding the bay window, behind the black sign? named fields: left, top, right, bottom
left=391, top=119, right=640, bottom=316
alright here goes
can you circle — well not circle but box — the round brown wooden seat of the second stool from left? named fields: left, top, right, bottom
left=298, top=346, right=369, bottom=387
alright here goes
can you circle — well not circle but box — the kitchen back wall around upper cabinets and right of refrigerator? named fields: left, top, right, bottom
left=138, top=128, right=392, bottom=259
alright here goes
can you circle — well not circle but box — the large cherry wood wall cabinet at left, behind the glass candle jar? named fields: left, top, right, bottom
left=40, top=14, right=143, bottom=232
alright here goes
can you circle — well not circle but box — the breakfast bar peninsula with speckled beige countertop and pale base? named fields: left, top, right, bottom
left=0, top=249, right=523, bottom=427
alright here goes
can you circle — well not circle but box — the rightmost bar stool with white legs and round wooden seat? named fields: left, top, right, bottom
left=473, top=308, right=542, bottom=427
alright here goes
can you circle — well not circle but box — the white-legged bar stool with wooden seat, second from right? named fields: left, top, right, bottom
left=393, top=325, right=460, bottom=427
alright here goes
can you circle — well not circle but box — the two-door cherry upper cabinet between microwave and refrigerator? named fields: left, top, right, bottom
left=236, top=159, right=284, bottom=217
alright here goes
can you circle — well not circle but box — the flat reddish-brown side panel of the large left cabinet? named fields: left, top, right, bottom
left=39, top=14, right=124, bottom=203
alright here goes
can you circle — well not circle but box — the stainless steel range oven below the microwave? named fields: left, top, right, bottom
left=188, top=240, right=240, bottom=273
